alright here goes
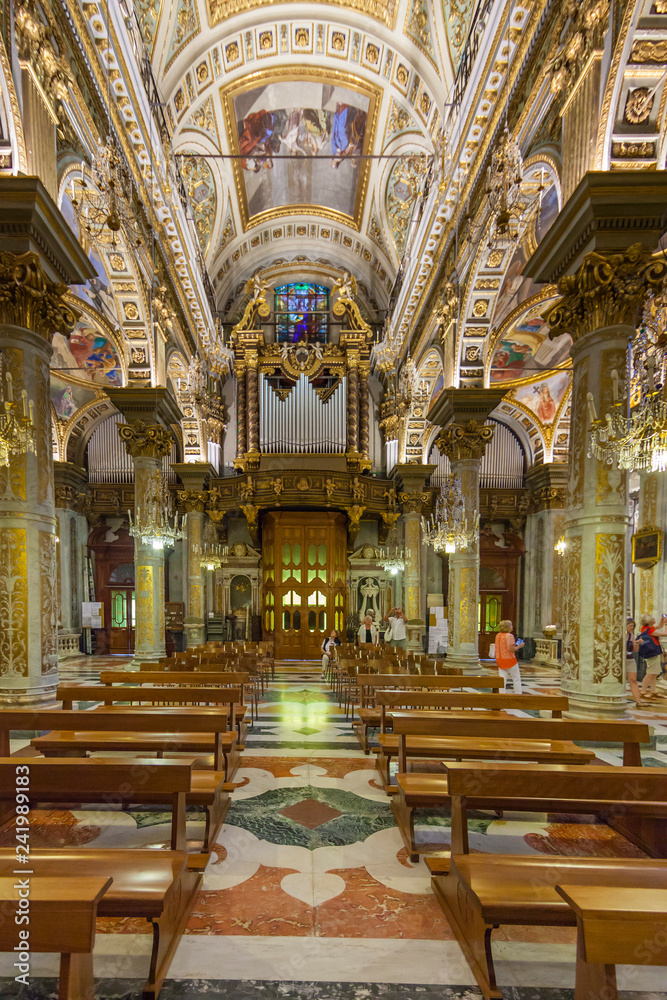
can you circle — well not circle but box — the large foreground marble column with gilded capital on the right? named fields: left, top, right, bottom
left=546, top=246, right=667, bottom=718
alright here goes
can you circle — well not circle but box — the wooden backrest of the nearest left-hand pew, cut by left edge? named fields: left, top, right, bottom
left=0, top=757, right=193, bottom=851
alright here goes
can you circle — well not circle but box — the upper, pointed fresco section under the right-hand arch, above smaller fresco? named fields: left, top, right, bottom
left=490, top=299, right=572, bottom=382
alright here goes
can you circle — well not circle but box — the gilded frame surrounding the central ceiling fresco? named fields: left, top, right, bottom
left=220, top=65, right=382, bottom=232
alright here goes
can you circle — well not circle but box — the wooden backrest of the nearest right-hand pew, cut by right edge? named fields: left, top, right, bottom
left=444, top=762, right=667, bottom=854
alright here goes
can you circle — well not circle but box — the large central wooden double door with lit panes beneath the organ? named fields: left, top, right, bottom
left=262, top=511, right=347, bottom=660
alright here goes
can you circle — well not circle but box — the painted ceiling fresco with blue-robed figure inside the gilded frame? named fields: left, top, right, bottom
left=230, top=79, right=370, bottom=225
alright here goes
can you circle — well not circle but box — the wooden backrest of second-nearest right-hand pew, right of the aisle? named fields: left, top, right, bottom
left=392, top=712, right=650, bottom=767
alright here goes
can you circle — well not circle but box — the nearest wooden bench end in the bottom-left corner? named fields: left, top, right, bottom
left=0, top=875, right=113, bottom=1000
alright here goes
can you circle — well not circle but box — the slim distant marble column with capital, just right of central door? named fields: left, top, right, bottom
left=395, top=465, right=436, bottom=652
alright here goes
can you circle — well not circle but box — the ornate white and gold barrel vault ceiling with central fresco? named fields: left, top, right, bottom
left=141, top=0, right=464, bottom=313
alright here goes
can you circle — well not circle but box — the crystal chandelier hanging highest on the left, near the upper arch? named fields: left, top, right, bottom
left=70, top=135, right=143, bottom=247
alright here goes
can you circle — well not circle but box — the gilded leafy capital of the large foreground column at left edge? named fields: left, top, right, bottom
left=0, top=251, right=81, bottom=343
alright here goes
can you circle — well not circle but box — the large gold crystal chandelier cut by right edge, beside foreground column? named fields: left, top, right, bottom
left=588, top=288, right=667, bottom=472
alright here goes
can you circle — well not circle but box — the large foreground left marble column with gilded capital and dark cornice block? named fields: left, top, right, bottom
left=0, top=177, right=93, bottom=707
